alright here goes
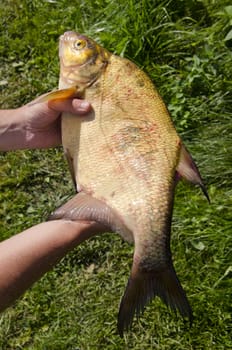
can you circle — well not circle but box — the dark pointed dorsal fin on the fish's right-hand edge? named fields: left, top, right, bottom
left=176, top=144, right=210, bottom=202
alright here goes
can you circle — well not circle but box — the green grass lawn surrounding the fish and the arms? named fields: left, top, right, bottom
left=0, top=0, right=232, bottom=350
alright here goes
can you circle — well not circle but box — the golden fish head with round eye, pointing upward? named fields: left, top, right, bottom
left=59, top=31, right=111, bottom=87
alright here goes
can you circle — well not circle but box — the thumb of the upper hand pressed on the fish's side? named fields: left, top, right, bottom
left=48, top=98, right=91, bottom=115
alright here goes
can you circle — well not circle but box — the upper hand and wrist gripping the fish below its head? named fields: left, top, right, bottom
left=0, top=98, right=91, bottom=151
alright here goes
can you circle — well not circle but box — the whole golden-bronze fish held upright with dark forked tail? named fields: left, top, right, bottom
left=39, top=31, right=209, bottom=337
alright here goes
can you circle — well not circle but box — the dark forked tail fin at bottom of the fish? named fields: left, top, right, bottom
left=118, top=266, right=193, bottom=337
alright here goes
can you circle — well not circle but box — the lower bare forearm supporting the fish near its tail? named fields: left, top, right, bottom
left=0, top=220, right=107, bottom=311
